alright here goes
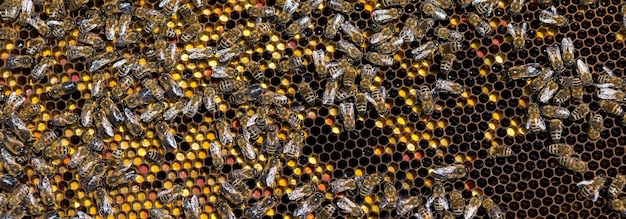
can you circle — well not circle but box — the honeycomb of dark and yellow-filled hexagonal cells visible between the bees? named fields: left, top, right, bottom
left=0, top=0, right=626, bottom=218
